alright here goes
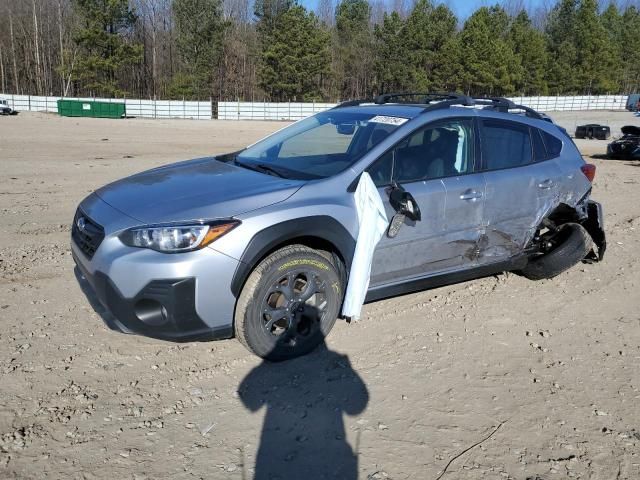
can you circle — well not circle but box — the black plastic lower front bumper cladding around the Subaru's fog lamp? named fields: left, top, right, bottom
left=74, top=254, right=233, bottom=342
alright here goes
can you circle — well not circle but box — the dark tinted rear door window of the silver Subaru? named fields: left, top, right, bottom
left=482, top=120, right=532, bottom=170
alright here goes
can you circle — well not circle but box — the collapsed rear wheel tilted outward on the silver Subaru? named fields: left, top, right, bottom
left=522, top=223, right=593, bottom=280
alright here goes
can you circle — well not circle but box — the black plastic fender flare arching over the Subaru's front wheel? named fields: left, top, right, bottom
left=231, top=215, right=356, bottom=298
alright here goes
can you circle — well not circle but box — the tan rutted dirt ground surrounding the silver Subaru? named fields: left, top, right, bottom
left=0, top=112, right=640, bottom=480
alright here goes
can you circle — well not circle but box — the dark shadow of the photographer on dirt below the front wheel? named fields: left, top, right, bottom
left=238, top=342, right=369, bottom=480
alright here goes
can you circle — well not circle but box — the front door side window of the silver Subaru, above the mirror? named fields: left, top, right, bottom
left=367, top=120, right=474, bottom=186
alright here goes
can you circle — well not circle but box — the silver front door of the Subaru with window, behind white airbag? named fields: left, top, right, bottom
left=367, top=118, right=485, bottom=287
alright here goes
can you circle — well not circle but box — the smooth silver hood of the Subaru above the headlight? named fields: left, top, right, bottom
left=96, top=157, right=304, bottom=223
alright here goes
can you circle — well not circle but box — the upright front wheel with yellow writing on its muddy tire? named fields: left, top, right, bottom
left=234, top=245, right=344, bottom=361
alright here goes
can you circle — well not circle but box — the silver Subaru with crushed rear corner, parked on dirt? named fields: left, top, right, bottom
left=71, top=94, right=606, bottom=360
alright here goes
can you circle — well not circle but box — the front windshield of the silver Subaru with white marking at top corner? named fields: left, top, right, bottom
left=235, top=110, right=407, bottom=180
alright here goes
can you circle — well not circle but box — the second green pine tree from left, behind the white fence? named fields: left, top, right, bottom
left=169, top=0, right=228, bottom=98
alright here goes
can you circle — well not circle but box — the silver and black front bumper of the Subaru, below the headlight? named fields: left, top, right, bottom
left=71, top=199, right=239, bottom=341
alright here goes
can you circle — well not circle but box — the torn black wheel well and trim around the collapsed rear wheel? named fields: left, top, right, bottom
left=529, top=197, right=607, bottom=262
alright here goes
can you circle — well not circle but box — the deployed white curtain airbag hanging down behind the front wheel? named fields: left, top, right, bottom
left=342, top=172, right=389, bottom=319
